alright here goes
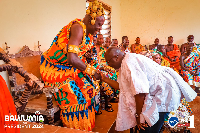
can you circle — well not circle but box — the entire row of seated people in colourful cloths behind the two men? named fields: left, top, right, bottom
left=90, top=34, right=200, bottom=114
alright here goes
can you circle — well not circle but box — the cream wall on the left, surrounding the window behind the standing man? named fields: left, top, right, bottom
left=0, top=0, right=121, bottom=88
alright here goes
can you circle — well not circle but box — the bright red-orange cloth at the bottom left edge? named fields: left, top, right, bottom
left=0, top=75, right=20, bottom=133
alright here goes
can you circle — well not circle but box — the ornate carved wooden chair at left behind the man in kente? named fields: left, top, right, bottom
left=0, top=46, right=60, bottom=125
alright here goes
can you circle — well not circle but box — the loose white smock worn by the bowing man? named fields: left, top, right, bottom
left=116, top=53, right=197, bottom=131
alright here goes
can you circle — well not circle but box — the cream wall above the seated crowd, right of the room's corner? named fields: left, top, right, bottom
left=121, top=0, right=200, bottom=45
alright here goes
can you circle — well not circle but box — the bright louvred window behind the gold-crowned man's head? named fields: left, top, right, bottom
left=86, top=0, right=111, bottom=38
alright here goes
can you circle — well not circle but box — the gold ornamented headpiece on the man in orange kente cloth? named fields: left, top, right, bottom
left=86, top=0, right=105, bottom=25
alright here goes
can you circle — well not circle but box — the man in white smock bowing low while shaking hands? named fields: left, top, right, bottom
left=101, top=47, right=197, bottom=133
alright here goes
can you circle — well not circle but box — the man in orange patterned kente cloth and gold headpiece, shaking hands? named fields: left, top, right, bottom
left=40, top=0, right=105, bottom=131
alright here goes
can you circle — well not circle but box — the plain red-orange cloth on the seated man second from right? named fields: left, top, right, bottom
left=167, top=44, right=181, bottom=70
